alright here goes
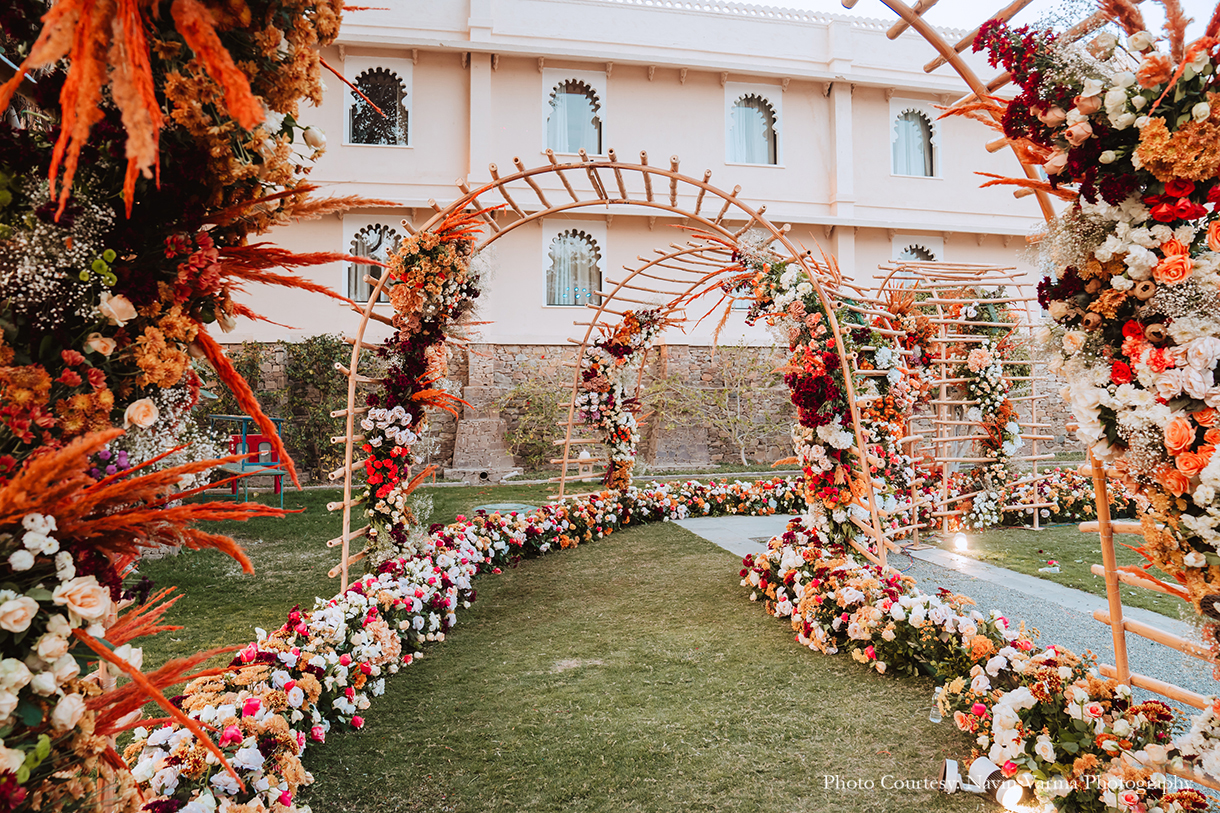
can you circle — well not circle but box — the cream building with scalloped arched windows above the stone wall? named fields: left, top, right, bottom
left=240, top=0, right=1041, bottom=468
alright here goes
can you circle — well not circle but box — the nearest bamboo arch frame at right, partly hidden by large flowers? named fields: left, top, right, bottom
left=841, top=0, right=1220, bottom=790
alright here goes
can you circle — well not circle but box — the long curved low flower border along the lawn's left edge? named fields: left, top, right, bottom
left=124, top=477, right=803, bottom=813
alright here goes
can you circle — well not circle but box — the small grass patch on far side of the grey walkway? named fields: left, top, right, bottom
left=936, top=524, right=1194, bottom=619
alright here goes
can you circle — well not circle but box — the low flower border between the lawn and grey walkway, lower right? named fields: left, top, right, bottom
left=741, top=518, right=1216, bottom=812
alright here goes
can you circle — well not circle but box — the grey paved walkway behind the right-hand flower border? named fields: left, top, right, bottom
left=676, top=515, right=1220, bottom=695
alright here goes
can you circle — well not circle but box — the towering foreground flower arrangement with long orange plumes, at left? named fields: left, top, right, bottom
left=0, top=0, right=405, bottom=812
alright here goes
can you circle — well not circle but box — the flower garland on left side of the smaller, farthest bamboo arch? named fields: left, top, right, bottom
left=575, top=309, right=673, bottom=490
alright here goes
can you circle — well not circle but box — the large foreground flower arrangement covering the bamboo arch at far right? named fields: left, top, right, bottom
left=975, top=7, right=1220, bottom=637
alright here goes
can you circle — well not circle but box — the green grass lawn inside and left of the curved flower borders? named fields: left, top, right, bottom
left=140, top=486, right=986, bottom=813
